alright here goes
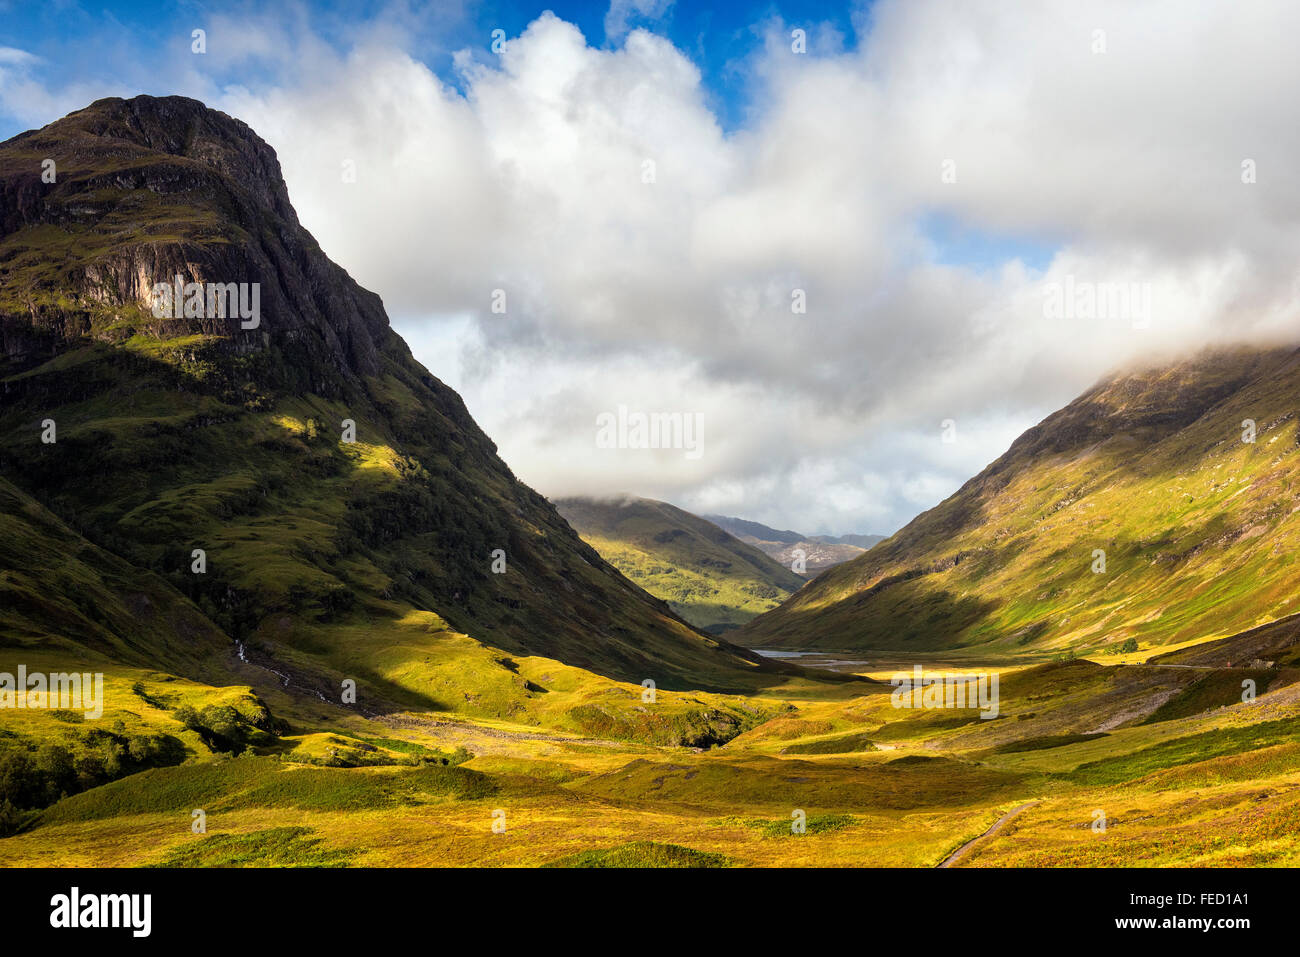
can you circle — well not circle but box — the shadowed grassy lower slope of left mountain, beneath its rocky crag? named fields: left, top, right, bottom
left=0, top=343, right=852, bottom=710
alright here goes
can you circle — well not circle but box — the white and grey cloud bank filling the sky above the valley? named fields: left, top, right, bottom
left=0, top=0, right=1300, bottom=533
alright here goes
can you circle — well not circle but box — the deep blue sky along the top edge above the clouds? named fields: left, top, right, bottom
left=0, top=0, right=870, bottom=138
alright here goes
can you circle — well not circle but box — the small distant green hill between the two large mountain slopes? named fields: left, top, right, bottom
left=555, top=498, right=803, bottom=633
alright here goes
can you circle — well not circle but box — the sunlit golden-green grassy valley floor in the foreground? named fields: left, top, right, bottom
left=0, top=634, right=1300, bottom=867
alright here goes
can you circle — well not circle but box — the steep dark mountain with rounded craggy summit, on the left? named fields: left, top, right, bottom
left=0, top=96, right=772, bottom=710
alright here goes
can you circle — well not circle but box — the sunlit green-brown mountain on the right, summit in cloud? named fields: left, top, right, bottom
left=736, top=347, right=1300, bottom=653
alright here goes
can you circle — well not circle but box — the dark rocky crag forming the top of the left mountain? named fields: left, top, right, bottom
left=0, top=96, right=391, bottom=378
